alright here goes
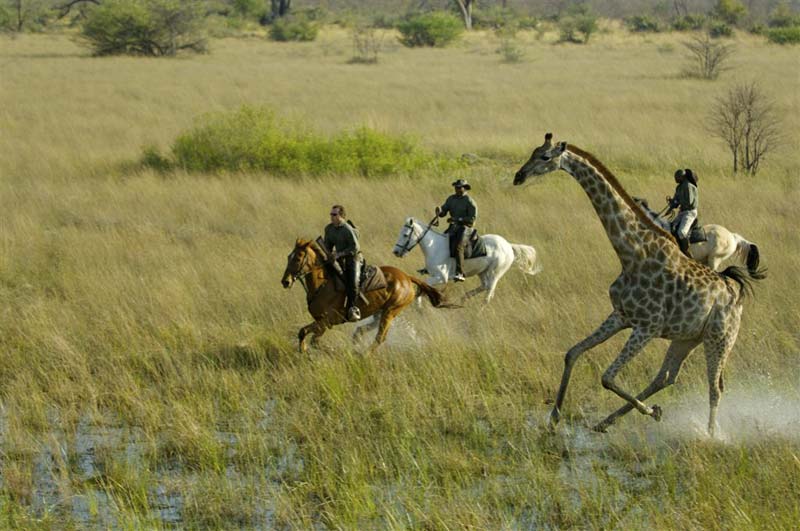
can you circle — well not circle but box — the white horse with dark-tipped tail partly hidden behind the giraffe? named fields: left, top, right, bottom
left=634, top=197, right=761, bottom=274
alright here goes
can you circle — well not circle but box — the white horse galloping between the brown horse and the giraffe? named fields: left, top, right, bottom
left=393, top=218, right=542, bottom=302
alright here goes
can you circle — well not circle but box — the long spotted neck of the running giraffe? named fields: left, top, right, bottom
left=561, top=147, right=668, bottom=270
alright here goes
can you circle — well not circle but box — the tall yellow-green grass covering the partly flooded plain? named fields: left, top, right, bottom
left=0, top=30, right=800, bottom=529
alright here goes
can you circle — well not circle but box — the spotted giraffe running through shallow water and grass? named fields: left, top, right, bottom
left=514, top=133, right=766, bottom=437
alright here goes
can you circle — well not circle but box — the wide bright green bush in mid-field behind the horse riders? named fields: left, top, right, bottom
left=169, top=107, right=455, bottom=177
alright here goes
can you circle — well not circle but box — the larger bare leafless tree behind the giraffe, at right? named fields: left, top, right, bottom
left=707, top=82, right=782, bottom=175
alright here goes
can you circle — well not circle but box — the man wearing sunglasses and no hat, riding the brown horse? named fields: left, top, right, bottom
left=324, top=205, right=364, bottom=322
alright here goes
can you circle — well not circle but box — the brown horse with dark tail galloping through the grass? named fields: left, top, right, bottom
left=281, top=238, right=444, bottom=353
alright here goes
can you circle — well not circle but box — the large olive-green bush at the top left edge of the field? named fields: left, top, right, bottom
left=80, top=0, right=207, bottom=56
